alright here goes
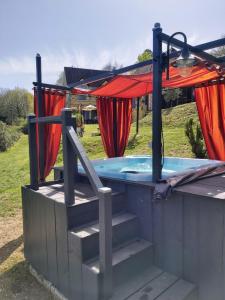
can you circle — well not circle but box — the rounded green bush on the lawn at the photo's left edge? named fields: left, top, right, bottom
left=0, top=121, right=20, bottom=152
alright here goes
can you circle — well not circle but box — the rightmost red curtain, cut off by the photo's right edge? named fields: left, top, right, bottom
left=195, top=83, right=225, bottom=161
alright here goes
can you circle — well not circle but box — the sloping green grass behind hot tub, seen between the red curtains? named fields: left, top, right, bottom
left=77, top=103, right=198, bottom=158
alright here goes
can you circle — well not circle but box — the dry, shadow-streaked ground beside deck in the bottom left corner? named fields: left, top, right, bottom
left=0, top=212, right=53, bottom=300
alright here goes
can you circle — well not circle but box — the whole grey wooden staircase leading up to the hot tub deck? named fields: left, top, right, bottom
left=68, top=188, right=198, bottom=300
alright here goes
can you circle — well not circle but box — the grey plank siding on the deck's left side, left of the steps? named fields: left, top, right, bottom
left=22, top=187, right=69, bottom=296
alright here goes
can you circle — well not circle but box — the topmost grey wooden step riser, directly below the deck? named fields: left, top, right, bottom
left=68, top=192, right=127, bottom=229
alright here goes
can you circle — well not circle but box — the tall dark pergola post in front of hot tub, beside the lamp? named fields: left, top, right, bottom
left=152, top=23, right=162, bottom=182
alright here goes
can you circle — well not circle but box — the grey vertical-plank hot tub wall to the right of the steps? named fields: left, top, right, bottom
left=153, top=192, right=225, bottom=300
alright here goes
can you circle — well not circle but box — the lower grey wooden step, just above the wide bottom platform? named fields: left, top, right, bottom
left=82, top=239, right=153, bottom=300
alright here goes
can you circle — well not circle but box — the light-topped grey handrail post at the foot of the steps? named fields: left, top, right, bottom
left=98, top=187, right=112, bottom=299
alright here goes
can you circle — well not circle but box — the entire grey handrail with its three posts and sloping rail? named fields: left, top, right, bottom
left=28, top=108, right=112, bottom=299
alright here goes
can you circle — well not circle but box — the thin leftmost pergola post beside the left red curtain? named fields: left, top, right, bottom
left=36, top=53, right=45, bottom=181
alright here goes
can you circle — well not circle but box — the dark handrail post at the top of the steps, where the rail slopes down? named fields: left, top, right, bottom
left=62, top=108, right=77, bottom=206
